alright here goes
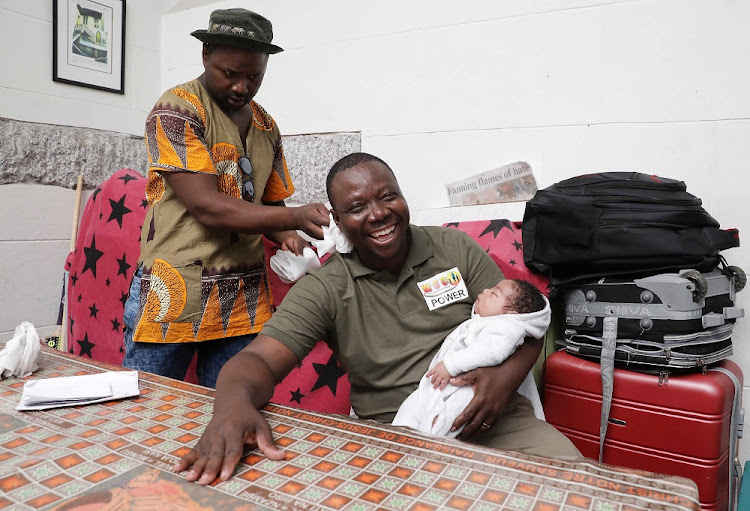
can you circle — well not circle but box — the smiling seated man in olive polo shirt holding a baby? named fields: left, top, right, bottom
left=174, top=153, right=580, bottom=484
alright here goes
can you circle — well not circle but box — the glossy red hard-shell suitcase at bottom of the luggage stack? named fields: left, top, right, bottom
left=544, top=351, right=743, bottom=510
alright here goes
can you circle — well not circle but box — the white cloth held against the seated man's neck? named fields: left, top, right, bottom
left=268, top=214, right=353, bottom=284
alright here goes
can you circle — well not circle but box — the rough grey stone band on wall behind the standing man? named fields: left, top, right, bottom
left=0, top=118, right=360, bottom=204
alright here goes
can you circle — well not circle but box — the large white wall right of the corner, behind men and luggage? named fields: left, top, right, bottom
left=162, top=0, right=750, bottom=463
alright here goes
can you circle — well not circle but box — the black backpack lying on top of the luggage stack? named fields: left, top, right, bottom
left=522, top=172, right=740, bottom=289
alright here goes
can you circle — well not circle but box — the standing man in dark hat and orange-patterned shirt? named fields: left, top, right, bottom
left=123, top=9, right=328, bottom=387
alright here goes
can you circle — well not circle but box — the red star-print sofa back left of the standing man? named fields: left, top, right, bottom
left=65, top=169, right=146, bottom=365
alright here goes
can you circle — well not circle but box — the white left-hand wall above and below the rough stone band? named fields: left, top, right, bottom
left=0, top=0, right=174, bottom=340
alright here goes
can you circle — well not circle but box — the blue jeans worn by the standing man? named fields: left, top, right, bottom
left=122, top=268, right=258, bottom=388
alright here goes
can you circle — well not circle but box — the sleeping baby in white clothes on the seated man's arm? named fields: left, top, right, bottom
left=393, top=280, right=550, bottom=437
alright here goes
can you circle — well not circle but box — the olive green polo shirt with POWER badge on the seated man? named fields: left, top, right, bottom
left=262, top=225, right=503, bottom=422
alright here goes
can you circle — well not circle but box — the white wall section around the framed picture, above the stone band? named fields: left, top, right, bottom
left=0, top=0, right=174, bottom=135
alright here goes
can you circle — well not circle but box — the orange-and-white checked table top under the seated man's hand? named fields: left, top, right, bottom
left=0, top=350, right=700, bottom=511
